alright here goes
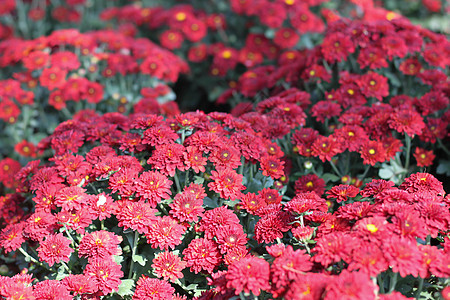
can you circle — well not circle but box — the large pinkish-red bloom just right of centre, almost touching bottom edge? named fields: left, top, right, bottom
left=225, top=256, right=270, bottom=296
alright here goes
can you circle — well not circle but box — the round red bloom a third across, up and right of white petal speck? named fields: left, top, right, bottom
left=135, top=171, right=172, bottom=207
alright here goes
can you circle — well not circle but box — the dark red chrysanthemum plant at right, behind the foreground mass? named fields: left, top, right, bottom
left=225, top=18, right=450, bottom=191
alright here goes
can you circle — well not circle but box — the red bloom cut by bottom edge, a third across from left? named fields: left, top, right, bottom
left=133, top=276, right=175, bottom=300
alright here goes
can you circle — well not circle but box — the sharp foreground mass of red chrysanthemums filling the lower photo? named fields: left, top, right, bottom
left=0, top=110, right=450, bottom=299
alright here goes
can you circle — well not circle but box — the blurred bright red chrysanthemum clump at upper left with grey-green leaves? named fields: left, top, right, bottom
left=0, top=29, right=188, bottom=161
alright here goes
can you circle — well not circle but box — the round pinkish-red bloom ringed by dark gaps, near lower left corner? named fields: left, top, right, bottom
left=37, top=233, right=73, bottom=266
